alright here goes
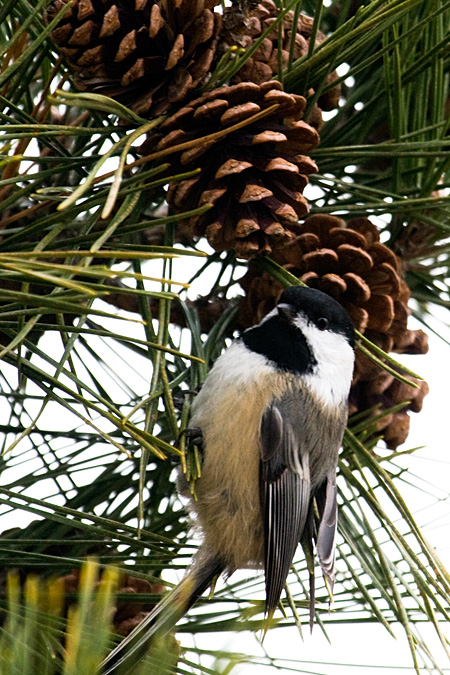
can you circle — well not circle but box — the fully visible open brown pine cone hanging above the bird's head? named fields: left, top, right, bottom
left=141, top=82, right=319, bottom=258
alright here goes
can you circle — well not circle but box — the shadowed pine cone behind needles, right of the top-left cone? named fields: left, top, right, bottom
left=217, top=0, right=341, bottom=127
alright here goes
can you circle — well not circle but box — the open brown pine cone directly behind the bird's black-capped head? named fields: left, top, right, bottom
left=239, top=215, right=428, bottom=448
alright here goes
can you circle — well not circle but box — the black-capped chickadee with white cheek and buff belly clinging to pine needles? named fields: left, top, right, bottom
left=101, top=285, right=355, bottom=675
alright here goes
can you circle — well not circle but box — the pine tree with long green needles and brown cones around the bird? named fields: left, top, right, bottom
left=0, top=0, right=450, bottom=675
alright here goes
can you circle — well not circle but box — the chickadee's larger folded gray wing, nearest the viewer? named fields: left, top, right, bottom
left=260, top=398, right=311, bottom=616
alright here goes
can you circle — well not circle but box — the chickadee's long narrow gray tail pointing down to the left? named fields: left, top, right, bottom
left=98, top=560, right=224, bottom=675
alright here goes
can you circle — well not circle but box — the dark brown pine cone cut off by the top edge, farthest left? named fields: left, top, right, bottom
left=44, top=0, right=221, bottom=116
